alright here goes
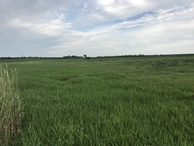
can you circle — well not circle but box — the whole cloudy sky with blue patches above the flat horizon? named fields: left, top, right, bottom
left=0, top=0, right=194, bottom=57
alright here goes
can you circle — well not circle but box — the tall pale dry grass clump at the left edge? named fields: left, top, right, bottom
left=0, top=64, right=22, bottom=146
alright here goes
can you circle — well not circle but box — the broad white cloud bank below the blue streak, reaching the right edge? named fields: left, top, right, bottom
left=46, top=2, right=194, bottom=56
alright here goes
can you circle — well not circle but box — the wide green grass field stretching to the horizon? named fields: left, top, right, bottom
left=0, top=55, right=194, bottom=146
